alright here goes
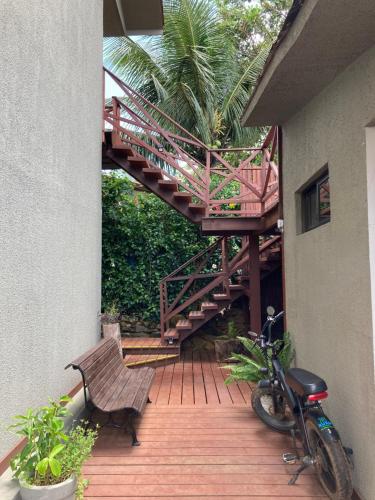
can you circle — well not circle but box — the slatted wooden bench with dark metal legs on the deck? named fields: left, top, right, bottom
left=65, top=338, right=155, bottom=446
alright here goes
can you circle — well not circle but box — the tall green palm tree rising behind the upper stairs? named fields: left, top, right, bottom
left=104, top=0, right=269, bottom=147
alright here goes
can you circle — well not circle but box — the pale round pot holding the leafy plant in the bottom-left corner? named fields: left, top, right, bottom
left=20, top=476, right=77, bottom=500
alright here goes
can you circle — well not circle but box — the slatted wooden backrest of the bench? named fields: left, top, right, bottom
left=66, top=338, right=129, bottom=400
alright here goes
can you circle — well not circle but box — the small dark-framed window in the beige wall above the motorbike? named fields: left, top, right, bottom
left=301, top=171, right=331, bottom=232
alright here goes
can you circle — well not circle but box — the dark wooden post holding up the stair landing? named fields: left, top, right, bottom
left=249, top=234, right=262, bottom=333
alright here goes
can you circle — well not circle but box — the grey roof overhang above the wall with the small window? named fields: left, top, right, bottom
left=242, top=0, right=375, bottom=126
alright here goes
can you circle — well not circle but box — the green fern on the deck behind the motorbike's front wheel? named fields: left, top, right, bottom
left=225, top=332, right=295, bottom=384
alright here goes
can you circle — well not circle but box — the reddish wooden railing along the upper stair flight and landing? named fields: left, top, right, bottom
left=103, top=68, right=279, bottom=217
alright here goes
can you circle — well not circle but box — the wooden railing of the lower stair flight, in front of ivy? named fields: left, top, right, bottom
left=160, top=236, right=280, bottom=337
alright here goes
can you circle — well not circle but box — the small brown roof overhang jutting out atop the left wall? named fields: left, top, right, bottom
left=103, top=0, right=164, bottom=36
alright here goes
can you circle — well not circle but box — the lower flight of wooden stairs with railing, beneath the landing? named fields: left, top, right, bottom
left=160, top=236, right=281, bottom=344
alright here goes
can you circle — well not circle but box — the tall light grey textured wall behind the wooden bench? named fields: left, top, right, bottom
left=0, top=0, right=103, bottom=454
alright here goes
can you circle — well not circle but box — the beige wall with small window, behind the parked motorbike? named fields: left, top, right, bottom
left=283, top=44, right=375, bottom=500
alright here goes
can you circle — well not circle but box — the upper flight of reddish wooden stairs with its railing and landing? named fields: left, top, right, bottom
left=102, top=69, right=279, bottom=235
